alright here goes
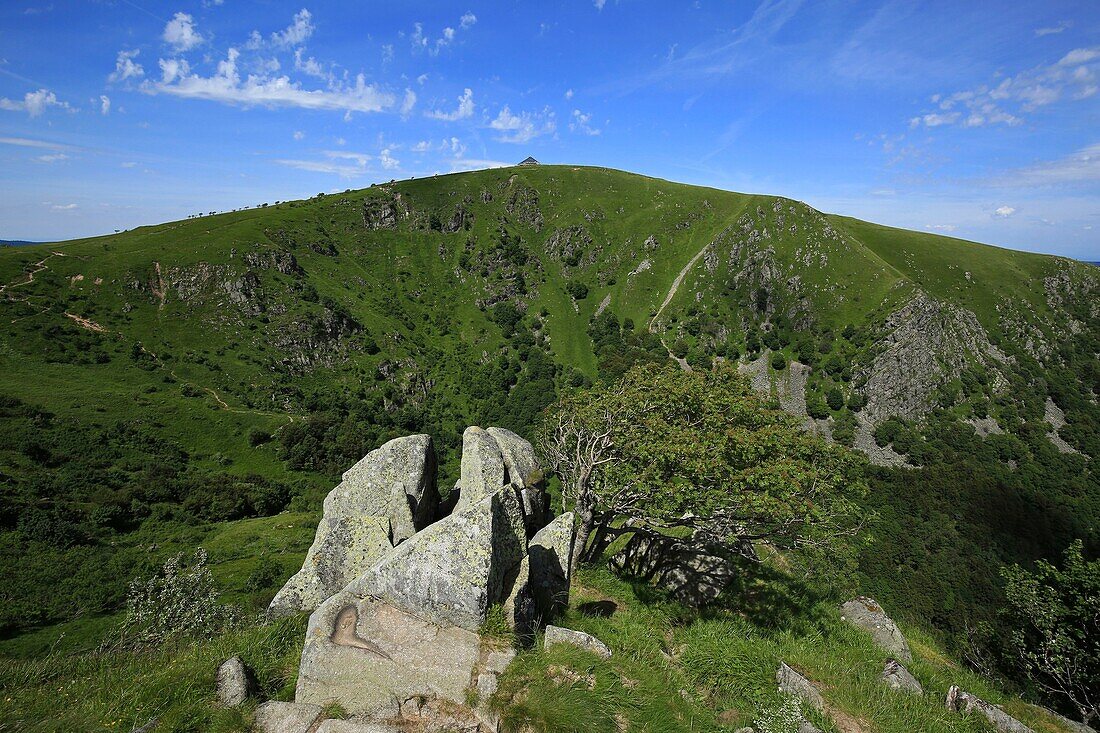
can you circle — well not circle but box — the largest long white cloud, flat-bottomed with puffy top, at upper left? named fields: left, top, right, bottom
left=142, top=48, right=395, bottom=113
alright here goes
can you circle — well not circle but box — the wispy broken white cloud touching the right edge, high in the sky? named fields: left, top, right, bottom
left=911, top=46, right=1100, bottom=128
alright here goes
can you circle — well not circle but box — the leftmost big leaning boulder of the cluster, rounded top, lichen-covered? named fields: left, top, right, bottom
left=268, top=435, right=439, bottom=615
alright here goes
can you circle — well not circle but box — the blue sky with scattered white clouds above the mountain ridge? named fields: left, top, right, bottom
left=0, top=0, right=1100, bottom=260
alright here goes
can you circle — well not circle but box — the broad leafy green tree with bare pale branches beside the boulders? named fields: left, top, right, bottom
left=538, top=364, right=866, bottom=571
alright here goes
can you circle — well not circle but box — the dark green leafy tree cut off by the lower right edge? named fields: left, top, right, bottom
left=1001, top=540, right=1100, bottom=725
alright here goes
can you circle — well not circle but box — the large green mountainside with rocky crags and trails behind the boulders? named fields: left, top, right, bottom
left=0, top=166, right=1100, bottom=730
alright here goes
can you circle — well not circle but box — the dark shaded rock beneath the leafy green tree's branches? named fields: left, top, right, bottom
left=608, top=534, right=734, bottom=608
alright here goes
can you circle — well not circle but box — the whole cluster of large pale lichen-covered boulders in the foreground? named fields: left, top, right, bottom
left=257, top=427, right=573, bottom=731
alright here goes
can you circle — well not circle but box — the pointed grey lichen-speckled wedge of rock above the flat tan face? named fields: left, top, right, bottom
left=348, top=479, right=527, bottom=631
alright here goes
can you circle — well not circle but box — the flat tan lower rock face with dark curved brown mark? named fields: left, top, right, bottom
left=295, top=591, right=481, bottom=719
